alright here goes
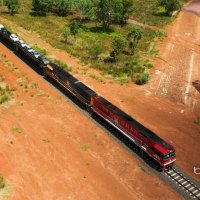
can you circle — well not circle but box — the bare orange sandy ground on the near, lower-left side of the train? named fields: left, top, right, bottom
left=0, top=44, right=181, bottom=200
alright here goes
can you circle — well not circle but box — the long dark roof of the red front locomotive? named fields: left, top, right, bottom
left=98, top=97, right=173, bottom=150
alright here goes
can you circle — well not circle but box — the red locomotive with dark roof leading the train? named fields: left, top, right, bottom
left=92, top=96, right=176, bottom=170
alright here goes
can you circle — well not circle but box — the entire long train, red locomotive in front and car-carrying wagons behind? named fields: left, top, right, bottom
left=0, top=24, right=176, bottom=171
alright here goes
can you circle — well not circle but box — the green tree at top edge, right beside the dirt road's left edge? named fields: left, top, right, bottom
left=157, top=0, right=181, bottom=15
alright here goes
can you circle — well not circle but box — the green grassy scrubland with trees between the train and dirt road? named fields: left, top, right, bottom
left=0, top=0, right=186, bottom=84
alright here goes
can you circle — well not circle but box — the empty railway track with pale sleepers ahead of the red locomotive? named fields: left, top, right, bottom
left=164, top=167, right=200, bottom=200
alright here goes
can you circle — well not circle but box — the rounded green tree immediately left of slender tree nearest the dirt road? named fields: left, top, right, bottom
left=110, top=34, right=127, bottom=61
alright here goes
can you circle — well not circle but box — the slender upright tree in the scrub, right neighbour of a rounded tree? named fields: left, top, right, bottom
left=127, top=27, right=142, bottom=55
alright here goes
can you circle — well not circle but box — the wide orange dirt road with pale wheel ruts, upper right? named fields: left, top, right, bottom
left=149, top=1, right=200, bottom=113
